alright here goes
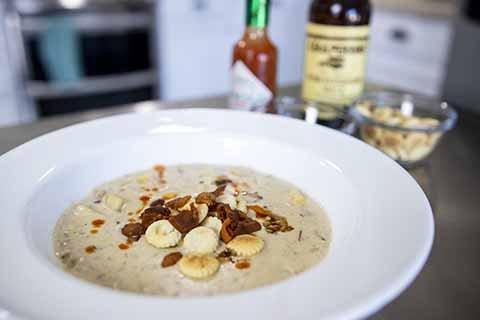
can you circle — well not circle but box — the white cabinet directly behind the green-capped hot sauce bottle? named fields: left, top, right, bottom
left=157, top=0, right=310, bottom=100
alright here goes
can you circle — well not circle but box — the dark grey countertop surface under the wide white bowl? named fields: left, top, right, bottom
left=0, top=87, right=480, bottom=319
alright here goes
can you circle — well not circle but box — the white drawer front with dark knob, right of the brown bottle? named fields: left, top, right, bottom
left=367, top=10, right=451, bottom=96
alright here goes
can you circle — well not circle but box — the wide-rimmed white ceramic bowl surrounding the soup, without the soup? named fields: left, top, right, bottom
left=0, top=109, right=433, bottom=320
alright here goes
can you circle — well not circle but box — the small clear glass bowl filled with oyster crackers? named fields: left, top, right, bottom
left=349, top=92, right=458, bottom=167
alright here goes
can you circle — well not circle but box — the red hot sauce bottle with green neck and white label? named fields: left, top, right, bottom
left=229, top=0, right=277, bottom=112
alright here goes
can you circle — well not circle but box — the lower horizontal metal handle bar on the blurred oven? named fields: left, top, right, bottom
left=27, top=70, right=157, bottom=99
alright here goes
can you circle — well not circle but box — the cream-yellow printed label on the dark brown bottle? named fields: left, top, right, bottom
left=302, top=23, right=369, bottom=106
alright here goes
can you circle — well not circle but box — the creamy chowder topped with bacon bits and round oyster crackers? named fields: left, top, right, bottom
left=54, top=164, right=331, bottom=296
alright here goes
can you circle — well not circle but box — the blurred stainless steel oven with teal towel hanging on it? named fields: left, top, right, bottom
left=7, top=0, right=157, bottom=116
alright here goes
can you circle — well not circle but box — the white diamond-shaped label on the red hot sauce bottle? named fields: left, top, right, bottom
left=229, top=60, right=273, bottom=111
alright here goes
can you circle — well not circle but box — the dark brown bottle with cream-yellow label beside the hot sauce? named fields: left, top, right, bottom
left=302, top=0, right=371, bottom=107
